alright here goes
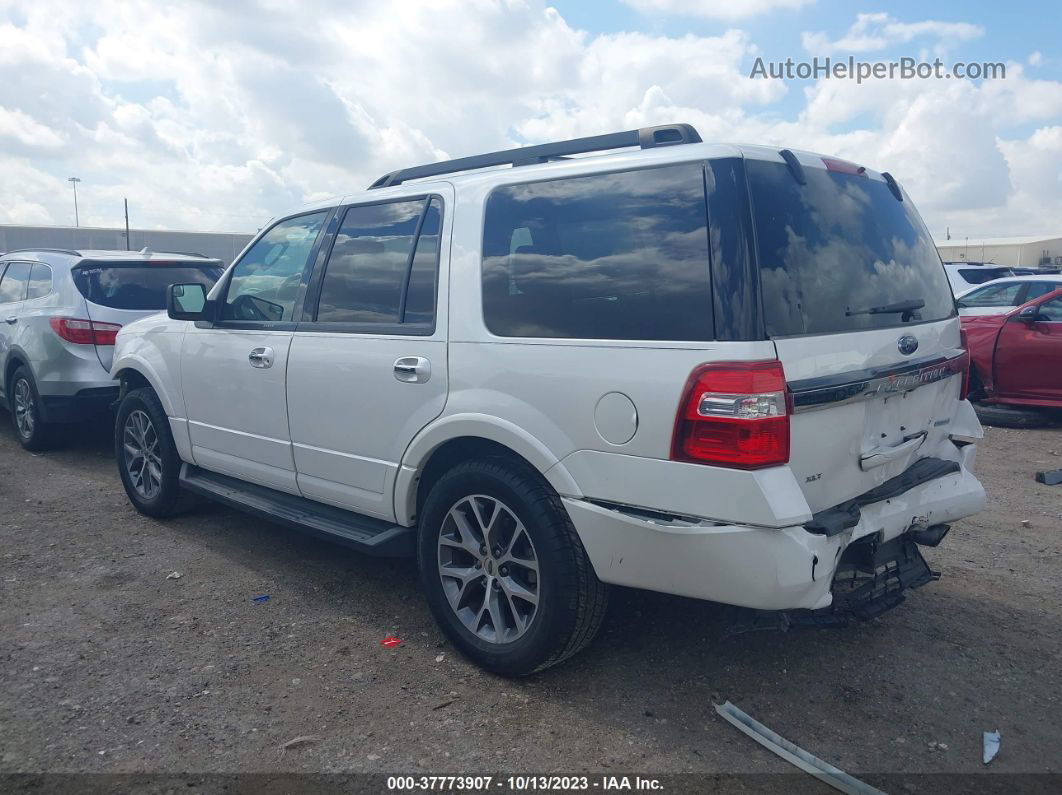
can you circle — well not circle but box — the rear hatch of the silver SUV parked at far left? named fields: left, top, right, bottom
left=73, top=257, right=224, bottom=370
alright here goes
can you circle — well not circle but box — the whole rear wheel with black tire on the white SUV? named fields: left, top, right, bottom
left=417, top=459, right=609, bottom=676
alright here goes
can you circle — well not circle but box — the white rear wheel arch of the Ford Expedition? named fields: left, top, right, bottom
left=394, top=415, right=582, bottom=526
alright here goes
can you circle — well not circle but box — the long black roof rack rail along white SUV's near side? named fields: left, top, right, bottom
left=369, top=124, right=701, bottom=190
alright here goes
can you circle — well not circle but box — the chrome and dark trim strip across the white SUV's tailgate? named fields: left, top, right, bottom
left=788, top=350, right=966, bottom=414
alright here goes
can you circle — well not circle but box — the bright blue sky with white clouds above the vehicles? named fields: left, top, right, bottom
left=0, top=0, right=1062, bottom=237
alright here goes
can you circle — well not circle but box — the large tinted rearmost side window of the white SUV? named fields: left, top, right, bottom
left=482, top=165, right=713, bottom=340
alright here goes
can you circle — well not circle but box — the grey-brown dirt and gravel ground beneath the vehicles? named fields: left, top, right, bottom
left=0, top=413, right=1062, bottom=792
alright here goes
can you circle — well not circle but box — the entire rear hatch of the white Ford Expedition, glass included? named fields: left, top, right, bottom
left=747, top=152, right=965, bottom=512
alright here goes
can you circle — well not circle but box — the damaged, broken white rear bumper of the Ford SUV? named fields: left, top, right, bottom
left=563, top=445, right=984, bottom=617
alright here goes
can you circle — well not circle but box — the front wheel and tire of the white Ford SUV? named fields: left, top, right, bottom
left=115, top=386, right=194, bottom=519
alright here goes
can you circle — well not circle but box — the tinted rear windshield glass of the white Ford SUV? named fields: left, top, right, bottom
left=748, top=160, right=955, bottom=336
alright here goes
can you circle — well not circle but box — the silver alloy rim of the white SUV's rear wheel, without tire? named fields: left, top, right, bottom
left=439, top=495, right=541, bottom=643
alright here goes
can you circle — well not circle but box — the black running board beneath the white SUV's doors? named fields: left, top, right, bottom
left=181, top=464, right=416, bottom=557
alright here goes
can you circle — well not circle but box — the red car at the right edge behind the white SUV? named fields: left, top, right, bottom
left=961, top=289, right=1062, bottom=409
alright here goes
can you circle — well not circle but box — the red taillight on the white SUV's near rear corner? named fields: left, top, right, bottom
left=671, top=361, right=789, bottom=469
